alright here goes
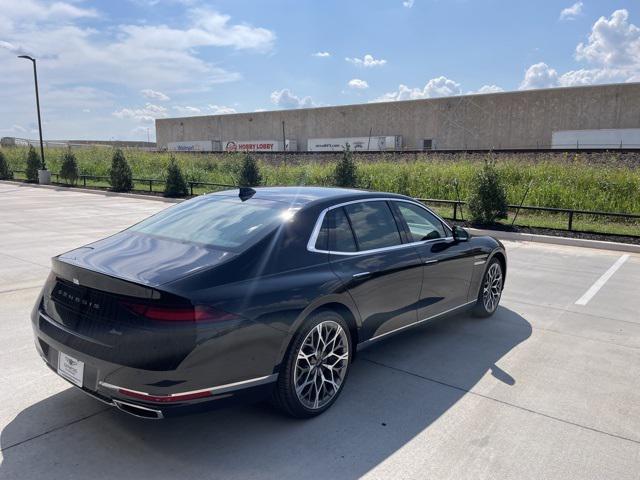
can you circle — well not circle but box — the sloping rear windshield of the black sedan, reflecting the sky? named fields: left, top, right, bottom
left=129, top=196, right=292, bottom=250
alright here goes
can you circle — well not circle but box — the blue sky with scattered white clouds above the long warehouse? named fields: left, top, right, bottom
left=0, top=0, right=640, bottom=140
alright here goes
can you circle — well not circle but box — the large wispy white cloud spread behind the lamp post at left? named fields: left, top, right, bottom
left=0, top=0, right=276, bottom=139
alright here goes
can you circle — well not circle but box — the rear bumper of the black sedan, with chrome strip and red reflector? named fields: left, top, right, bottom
left=32, top=308, right=278, bottom=419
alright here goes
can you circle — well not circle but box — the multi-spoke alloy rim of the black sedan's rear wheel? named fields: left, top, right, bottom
left=293, top=320, right=349, bottom=410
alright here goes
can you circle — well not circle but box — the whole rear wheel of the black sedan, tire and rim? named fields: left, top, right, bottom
left=272, top=310, right=353, bottom=418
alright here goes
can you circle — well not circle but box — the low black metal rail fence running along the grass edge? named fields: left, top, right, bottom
left=6, top=170, right=640, bottom=238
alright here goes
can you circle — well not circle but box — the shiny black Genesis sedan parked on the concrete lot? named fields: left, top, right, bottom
left=31, top=187, right=506, bottom=418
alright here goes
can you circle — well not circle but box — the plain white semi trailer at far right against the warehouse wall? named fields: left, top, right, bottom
left=551, top=128, right=640, bottom=148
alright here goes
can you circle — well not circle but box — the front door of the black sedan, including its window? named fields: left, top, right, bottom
left=392, top=201, right=474, bottom=320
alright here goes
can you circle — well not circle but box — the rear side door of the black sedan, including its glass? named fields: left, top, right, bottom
left=316, top=200, right=422, bottom=340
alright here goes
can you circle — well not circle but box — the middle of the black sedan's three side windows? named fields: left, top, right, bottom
left=344, top=201, right=402, bottom=251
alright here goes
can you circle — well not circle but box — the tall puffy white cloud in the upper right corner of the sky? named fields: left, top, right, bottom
left=576, top=10, right=640, bottom=68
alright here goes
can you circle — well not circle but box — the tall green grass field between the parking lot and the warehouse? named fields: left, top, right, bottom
left=3, top=148, right=640, bottom=235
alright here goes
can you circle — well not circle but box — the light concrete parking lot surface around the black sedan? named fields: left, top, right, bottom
left=0, top=182, right=640, bottom=479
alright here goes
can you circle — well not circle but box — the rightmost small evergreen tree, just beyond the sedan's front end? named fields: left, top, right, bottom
left=469, top=160, right=507, bottom=224
